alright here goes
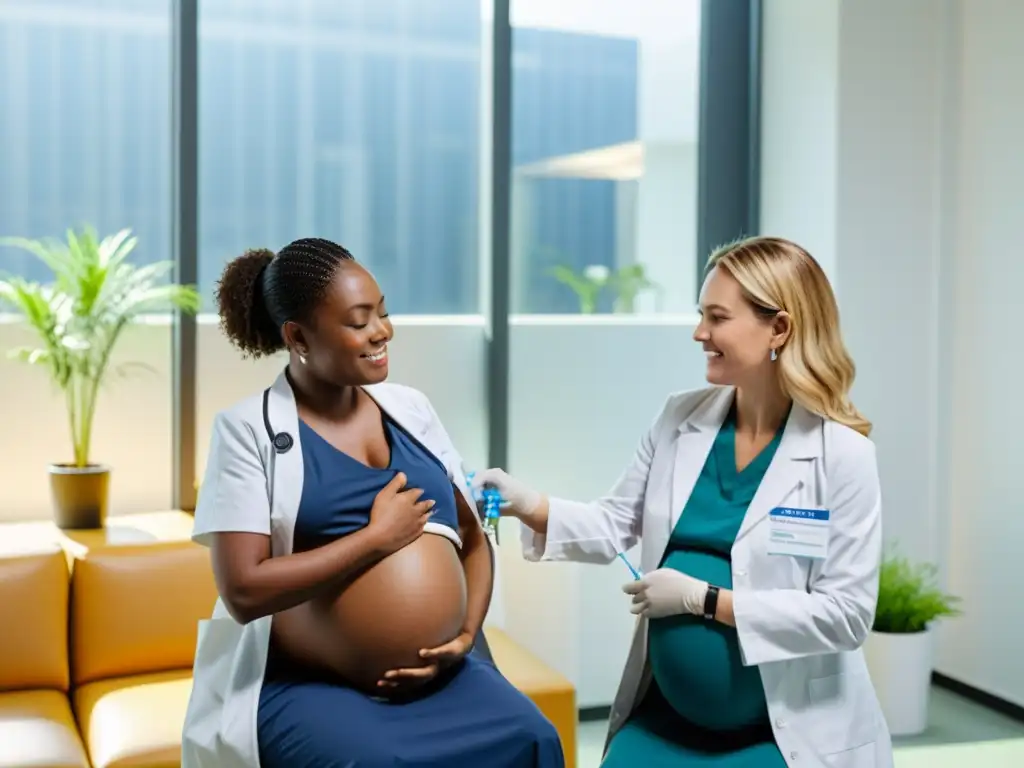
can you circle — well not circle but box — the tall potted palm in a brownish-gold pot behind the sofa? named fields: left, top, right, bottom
left=0, top=228, right=200, bottom=528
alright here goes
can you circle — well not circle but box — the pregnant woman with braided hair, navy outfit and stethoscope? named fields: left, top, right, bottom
left=182, top=239, right=564, bottom=768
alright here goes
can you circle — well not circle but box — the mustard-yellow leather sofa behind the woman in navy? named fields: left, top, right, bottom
left=0, top=513, right=577, bottom=768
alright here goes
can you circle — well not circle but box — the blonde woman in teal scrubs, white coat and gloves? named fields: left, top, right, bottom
left=476, top=238, right=893, bottom=768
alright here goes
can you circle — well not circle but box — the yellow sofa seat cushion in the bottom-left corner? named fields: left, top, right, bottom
left=0, top=692, right=89, bottom=768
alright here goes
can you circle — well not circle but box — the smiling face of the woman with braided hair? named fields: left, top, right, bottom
left=285, top=261, right=394, bottom=386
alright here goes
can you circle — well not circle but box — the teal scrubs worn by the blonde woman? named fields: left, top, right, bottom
left=601, top=410, right=785, bottom=768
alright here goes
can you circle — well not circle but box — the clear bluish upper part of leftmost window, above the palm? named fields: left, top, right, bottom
left=0, top=0, right=171, bottom=281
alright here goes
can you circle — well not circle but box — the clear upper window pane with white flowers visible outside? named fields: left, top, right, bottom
left=512, top=0, right=700, bottom=314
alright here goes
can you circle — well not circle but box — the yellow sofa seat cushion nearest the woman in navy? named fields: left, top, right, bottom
left=73, top=670, right=191, bottom=768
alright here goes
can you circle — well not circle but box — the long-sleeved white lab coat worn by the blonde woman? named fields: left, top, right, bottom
left=523, top=387, right=893, bottom=768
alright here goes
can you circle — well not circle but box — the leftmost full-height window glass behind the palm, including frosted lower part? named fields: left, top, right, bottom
left=0, top=0, right=172, bottom=519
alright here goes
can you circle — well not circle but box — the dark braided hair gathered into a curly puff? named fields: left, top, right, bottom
left=216, top=238, right=355, bottom=357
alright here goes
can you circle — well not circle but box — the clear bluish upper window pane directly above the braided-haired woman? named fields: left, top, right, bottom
left=199, top=0, right=490, bottom=314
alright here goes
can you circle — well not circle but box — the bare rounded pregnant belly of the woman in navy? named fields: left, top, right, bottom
left=273, top=534, right=466, bottom=692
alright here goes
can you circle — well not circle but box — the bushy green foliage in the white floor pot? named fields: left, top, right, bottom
left=872, top=546, right=961, bottom=634
